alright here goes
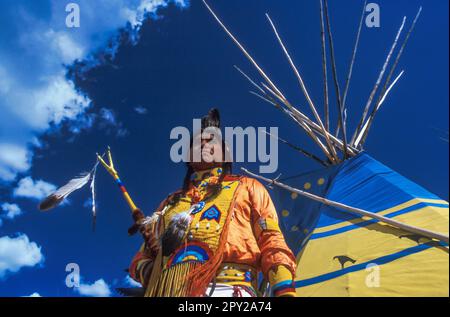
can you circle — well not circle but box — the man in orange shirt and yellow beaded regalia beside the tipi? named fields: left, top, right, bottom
left=129, top=109, right=295, bottom=297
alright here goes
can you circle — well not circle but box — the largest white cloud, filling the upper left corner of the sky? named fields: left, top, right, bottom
left=0, top=0, right=189, bottom=182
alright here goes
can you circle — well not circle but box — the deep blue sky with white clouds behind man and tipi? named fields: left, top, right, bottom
left=0, top=0, right=449, bottom=296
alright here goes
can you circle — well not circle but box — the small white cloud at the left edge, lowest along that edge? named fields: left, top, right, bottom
left=0, top=234, right=44, bottom=278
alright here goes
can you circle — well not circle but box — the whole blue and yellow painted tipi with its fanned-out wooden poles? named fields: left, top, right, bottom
left=203, top=0, right=449, bottom=296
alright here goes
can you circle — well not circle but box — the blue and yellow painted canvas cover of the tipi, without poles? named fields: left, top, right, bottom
left=274, top=153, right=449, bottom=296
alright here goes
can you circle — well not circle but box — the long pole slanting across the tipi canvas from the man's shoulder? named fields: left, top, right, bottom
left=241, top=167, right=449, bottom=244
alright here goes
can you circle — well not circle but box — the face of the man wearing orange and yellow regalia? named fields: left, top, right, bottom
left=190, top=130, right=224, bottom=170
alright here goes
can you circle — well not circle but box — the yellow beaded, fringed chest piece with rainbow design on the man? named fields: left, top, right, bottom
left=146, top=175, right=239, bottom=296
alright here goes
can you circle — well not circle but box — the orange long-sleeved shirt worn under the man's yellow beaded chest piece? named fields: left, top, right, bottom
left=129, top=172, right=296, bottom=296
